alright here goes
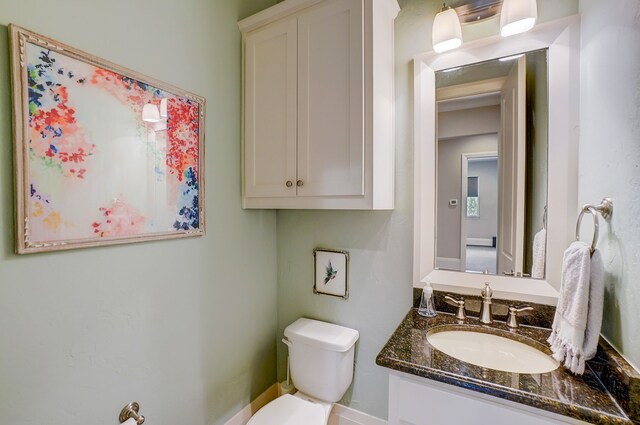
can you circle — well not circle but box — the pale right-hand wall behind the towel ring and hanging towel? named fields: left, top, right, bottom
left=579, top=0, right=640, bottom=367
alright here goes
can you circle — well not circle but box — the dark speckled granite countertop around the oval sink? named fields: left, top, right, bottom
left=376, top=308, right=633, bottom=424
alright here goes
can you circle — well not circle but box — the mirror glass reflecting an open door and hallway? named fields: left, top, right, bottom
left=436, top=50, right=548, bottom=279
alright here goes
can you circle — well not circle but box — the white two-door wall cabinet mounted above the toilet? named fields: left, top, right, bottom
left=239, top=0, right=399, bottom=209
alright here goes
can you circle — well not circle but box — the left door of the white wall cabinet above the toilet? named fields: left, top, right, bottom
left=244, top=18, right=297, bottom=197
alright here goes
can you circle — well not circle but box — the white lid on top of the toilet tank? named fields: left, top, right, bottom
left=284, top=317, right=360, bottom=352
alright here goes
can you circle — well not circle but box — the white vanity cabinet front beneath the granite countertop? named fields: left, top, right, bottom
left=389, top=372, right=586, bottom=425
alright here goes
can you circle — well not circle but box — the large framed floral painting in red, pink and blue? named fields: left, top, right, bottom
left=9, top=25, right=205, bottom=253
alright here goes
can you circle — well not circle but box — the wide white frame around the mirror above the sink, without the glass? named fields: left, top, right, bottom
left=413, top=15, right=580, bottom=305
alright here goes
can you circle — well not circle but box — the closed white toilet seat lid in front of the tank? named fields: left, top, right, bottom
left=247, top=394, right=327, bottom=425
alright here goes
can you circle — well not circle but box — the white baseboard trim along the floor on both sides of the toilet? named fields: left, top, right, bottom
left=225, top=383, right=387, bottom=425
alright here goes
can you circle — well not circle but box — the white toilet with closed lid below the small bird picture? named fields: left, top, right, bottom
left=247, top=318, right=359, bottom=425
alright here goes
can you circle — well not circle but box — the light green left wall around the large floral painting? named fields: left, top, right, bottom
left=0, top=0, right=277, bottom=425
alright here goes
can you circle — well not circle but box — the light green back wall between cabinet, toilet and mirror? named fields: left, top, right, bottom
left=277, top=0, right=578, bottom=418
